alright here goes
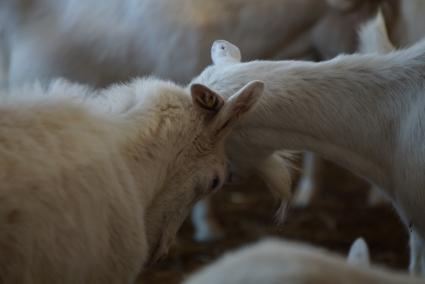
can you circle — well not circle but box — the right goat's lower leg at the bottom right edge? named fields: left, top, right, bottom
left=409, top=231, right=425, bottom=275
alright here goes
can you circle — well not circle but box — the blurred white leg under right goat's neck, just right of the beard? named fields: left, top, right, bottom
left=292, top=152, right=320, bottom=208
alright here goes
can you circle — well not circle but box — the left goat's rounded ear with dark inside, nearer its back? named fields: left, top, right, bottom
left=190, top=84, right=224, bottom=114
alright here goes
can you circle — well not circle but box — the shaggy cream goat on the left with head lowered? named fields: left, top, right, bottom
left=0, top=76, right=263, bottom=283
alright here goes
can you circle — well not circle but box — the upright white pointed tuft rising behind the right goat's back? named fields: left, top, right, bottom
left=359, top=9, right=395, bottom=53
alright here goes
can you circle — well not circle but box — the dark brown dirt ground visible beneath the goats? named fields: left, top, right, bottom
left=138, top=159, right=408, bottom=284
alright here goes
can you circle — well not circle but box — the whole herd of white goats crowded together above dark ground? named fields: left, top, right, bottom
left=0, top=0, right=425, bottom=284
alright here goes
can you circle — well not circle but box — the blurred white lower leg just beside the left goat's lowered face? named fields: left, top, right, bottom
left=192, top=197, right=223, bottom=242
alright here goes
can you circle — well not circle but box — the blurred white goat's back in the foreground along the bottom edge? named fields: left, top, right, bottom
left=184, top=239, right=425, bottom=284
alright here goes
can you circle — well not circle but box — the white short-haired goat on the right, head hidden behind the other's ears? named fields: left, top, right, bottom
left=193, top=23, right=425, bottom=274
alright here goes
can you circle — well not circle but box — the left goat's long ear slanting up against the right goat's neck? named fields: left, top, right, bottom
left=215, top=81, right=264, bottom=137
